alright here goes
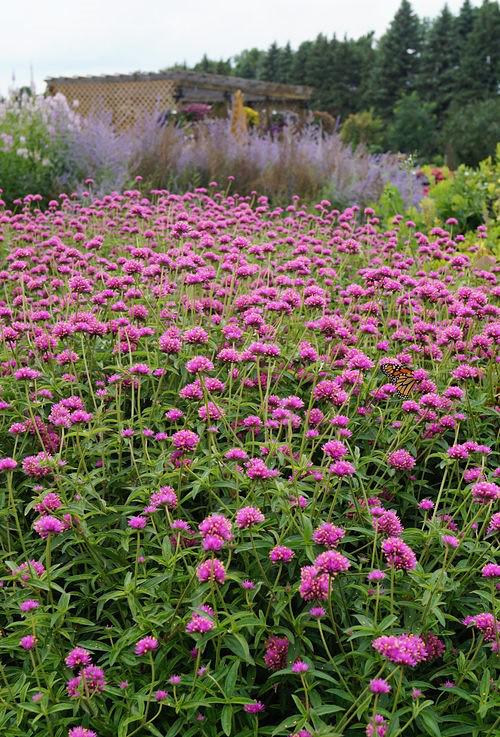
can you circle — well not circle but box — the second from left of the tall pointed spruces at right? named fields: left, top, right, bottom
left=418, top=5, right=460, bottom=117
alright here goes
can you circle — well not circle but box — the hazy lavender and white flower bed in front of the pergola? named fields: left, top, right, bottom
left=0, top=95, right=423, bottom=207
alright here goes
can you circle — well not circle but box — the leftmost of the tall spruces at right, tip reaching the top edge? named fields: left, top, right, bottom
left=371, top=0, right=422, bottom=117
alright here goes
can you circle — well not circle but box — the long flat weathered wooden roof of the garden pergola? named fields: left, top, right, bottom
left=45, top=70, right=313, bottom=101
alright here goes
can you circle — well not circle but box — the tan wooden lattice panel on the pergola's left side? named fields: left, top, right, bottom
left=52, top=79, right=177, bottom=130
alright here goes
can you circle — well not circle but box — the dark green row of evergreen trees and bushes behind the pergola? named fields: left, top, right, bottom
left=167, top=0, right=500, bottom=165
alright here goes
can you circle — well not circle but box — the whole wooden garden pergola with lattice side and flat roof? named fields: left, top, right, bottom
left=46, top=70, right=312, bottom=130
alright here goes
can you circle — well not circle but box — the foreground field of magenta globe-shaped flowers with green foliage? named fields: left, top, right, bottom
left=0, top=187, right=500, bottom=737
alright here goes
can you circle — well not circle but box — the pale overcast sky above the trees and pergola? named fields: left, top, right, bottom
left=0, top=0, right=472, bottom=93
